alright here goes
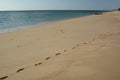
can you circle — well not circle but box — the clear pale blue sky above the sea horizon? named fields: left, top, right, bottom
left=0, top=0, right=120, bottom=10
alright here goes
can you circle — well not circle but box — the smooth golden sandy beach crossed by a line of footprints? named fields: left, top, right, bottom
left=0, top=11, right=120, bottom=80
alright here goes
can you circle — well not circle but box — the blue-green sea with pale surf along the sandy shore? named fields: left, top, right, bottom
left=0, top=10, right=105, bottom=33
